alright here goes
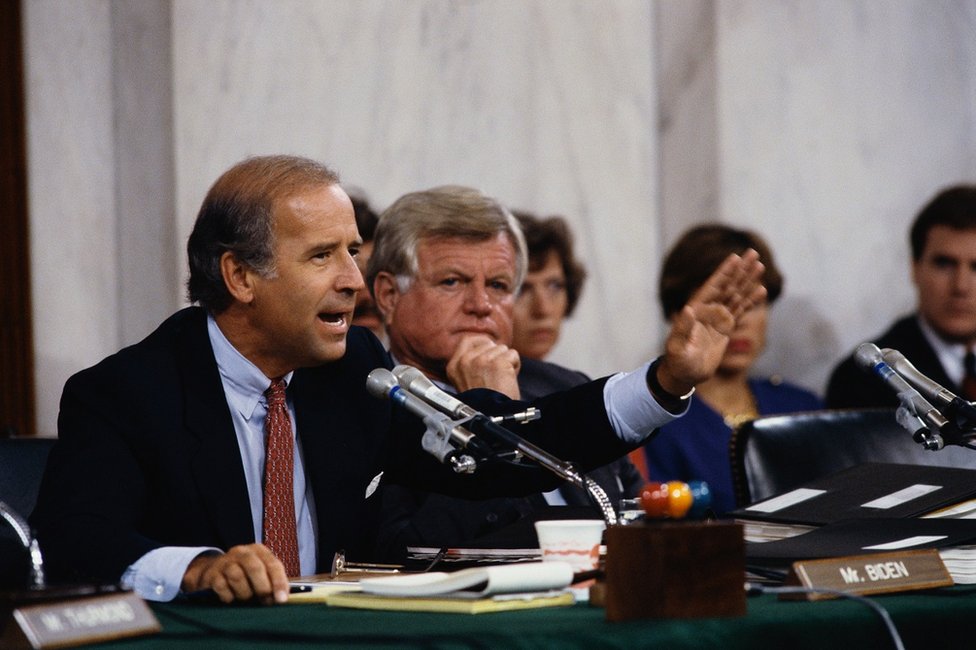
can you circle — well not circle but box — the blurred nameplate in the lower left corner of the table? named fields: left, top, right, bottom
left=0, top=592, right=161, bottom=650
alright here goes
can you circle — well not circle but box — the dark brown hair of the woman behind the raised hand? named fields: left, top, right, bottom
left=659, top=224, right=783, bottom=319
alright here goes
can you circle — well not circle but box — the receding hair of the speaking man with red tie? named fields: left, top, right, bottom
left=186, top=156, right=339, bottom=314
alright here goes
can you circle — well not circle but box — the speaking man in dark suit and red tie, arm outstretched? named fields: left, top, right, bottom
left=31, top=156, right=762, bottom=603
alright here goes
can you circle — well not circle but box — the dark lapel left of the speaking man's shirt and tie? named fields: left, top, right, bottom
left=179, top=310, right=255, bottom=548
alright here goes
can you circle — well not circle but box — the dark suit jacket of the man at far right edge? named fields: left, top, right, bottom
left=826, top=314, right=962, bottom=408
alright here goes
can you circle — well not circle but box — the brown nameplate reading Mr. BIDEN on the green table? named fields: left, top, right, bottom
left=780, top=549, right=954, bottom=600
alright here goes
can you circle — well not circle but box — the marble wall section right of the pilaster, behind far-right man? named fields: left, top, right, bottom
left=708, top=0, right=976, bottom=388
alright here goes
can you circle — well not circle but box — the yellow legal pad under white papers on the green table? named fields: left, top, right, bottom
left=325, top=591, right=575, bottom=614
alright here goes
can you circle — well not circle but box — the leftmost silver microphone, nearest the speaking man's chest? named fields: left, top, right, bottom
left=366, top=368, right=490, bottom=473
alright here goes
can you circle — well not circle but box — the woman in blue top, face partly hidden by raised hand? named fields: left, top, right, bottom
left=644, top=224, right=823, bottom=516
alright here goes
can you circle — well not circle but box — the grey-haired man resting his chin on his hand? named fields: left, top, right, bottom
left=366, top=186, right=644, bottom=554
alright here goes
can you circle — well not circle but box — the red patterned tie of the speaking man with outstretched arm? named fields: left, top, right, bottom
left=263, top=378, right=301, bottom=577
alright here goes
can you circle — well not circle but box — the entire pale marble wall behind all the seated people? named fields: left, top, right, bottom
left=24, top=0, right=976, bottom=433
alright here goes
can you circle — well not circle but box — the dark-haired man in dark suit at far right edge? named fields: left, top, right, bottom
left=826, top=185, right=976, bottom=408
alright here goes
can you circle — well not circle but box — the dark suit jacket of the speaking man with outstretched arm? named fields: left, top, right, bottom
left=31, top=307, right=627, bottom=582
